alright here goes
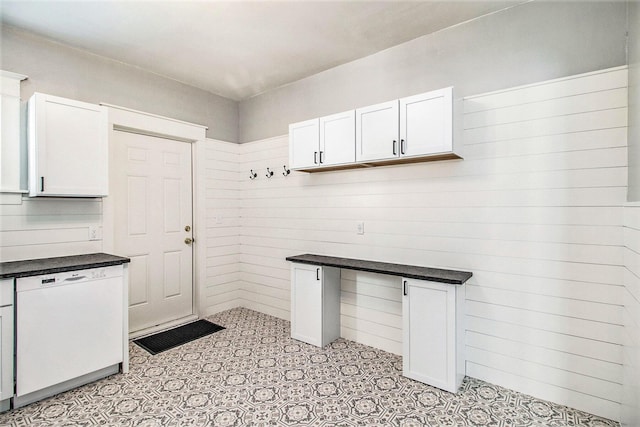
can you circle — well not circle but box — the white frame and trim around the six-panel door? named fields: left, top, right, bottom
left=100, top=103, right=207, bottom=339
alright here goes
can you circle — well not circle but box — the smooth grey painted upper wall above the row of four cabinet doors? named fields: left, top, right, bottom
left=239, top=1, right=627, bottom=142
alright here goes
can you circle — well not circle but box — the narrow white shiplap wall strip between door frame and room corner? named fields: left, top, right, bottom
left=199, top=139, right=243, bottom=315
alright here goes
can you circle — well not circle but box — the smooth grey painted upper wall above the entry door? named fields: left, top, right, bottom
left=0, top=24, right=238, bottom=142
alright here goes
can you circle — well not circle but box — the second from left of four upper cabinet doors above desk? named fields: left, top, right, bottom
left=319, top=110, right=356, bottom=166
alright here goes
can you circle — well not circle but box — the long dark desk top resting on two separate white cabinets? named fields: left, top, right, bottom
left=286, top=254, right=473, bottom=285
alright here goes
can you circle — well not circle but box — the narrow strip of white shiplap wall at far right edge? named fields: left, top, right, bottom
left=621, top=204, right=640, bottom=426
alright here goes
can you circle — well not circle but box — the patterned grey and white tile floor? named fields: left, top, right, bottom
left=0, top=308, right=617, bottom=427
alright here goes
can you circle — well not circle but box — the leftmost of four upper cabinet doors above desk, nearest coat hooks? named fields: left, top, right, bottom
left=289, top=119, right=320, bottom=169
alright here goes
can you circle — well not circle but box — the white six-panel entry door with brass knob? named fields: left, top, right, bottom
left=111, top=131, right=193, bottom=332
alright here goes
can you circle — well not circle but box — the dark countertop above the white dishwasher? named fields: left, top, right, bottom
left=0, top=253, right=130, bottom=279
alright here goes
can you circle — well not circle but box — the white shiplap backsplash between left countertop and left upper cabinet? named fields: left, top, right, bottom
left=0, top=196, right=102, bottom=262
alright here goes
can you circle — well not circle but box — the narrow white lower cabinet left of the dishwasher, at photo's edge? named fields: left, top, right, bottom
left=0, top=279, right=14, bottom=411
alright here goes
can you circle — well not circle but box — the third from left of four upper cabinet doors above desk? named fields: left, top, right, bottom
left=356, top=100, right=400, bottom=162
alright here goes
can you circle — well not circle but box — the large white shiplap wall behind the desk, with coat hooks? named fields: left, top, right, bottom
left=239, top=68, right=624, bottom=419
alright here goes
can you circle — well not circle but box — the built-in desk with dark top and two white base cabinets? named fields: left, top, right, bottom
left=286, top=254, right=472, bottom=393
